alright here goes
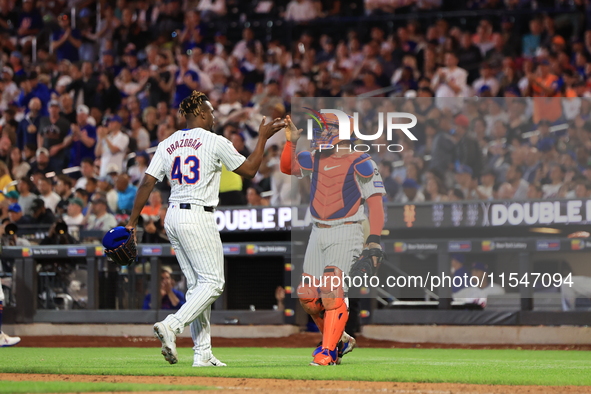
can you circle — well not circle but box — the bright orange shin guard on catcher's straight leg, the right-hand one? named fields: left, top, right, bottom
left=320, top=266, right=349, bottom=350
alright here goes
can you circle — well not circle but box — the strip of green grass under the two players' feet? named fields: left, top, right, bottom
left=0, top=347, right=591, bottom=391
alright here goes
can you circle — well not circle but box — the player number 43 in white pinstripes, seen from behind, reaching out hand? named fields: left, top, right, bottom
left=127, top=91, right=286, bottom=367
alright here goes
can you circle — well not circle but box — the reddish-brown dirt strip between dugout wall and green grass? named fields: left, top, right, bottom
left=19, top=333, right=591, bottom=350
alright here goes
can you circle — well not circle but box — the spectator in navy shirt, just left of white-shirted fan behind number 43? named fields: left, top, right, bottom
left=64, top=104, right=96, bottom=167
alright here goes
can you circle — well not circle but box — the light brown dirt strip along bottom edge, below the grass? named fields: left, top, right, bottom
left=0, top=373, right=591, bottom=394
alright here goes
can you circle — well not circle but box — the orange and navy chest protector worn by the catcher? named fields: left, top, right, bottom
left=310, top=153, right=370, bottom=220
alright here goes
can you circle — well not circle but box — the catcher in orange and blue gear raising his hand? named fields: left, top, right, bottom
left=281, top=114, right=385, bottom=366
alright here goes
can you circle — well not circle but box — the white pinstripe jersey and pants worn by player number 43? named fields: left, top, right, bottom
left=146, top=128, right=246, bottom=361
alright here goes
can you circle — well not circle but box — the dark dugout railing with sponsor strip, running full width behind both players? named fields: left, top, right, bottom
left=2, top=238, right=590, bottom=325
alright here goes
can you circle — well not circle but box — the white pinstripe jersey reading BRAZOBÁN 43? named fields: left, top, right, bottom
left=146, top=128, right=246, bottom=207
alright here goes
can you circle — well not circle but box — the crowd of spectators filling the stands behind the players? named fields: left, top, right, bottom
left=0, top=0, right=591, bottom=240
